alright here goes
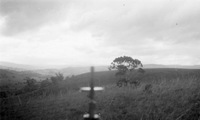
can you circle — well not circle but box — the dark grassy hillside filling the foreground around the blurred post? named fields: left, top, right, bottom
left=0, top=69, right=200, bottom=120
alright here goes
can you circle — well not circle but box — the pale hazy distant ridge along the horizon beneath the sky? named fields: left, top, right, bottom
left=0, top=62, right=200, bottom=76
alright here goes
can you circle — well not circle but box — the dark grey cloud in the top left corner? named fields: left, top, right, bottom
left=0, top=0, right=70, bottom=36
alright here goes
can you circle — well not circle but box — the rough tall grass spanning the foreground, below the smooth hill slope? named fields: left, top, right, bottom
left=1, top=70, right=200, bottom=120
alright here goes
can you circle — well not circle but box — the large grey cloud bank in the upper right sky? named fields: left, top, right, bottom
left=72, top=0, right=200, bottom=45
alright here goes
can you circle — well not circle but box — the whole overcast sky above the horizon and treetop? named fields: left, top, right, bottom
left=0, top=0, right=200, bottom=66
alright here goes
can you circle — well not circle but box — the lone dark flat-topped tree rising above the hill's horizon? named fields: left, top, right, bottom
left=108, top=56, right=144, bottom=87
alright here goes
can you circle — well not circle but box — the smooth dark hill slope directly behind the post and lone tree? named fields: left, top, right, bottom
left=66, top=68, right=200, bottom=88
